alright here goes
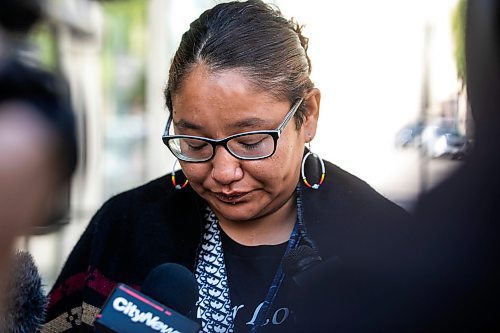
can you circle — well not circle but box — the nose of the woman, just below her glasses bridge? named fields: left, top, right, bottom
left=212, top=146, right=243, bottom=185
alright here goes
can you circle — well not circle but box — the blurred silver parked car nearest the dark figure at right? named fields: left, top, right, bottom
left=421, top=118, right=470, bottom=159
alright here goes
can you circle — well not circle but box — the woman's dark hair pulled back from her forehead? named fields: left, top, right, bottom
left=165, top=0, right=314, bottom=128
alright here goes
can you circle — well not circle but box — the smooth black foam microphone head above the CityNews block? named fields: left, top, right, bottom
left=141, top=263, right=198, bottom=316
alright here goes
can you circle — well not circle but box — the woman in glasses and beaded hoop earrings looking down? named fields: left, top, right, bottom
left=42, top=1, right=406, bottom=332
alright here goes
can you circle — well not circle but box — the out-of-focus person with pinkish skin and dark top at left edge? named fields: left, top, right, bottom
left=0, top=57, right=76, bottom=319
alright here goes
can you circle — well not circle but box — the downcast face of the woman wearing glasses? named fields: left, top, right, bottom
left=172, top=65, right=319, bottom=221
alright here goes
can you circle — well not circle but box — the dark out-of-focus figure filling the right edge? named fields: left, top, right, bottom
left=406, top=0, right=500, bottom=332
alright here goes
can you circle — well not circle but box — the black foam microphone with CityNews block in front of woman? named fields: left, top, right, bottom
left=94, top=263, right=201, bottom=333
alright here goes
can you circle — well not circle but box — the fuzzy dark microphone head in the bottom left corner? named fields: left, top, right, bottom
left=0, top=252, right=47, bottom=333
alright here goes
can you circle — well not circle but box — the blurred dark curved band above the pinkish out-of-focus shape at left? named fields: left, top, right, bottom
left=0, top=57, right=77, bottom=181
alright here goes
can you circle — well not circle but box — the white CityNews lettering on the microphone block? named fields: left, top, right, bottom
left=113, top=297, right=182, bottom=333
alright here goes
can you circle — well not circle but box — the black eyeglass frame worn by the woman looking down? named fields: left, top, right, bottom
left=162, top=98, right=304, bottom=163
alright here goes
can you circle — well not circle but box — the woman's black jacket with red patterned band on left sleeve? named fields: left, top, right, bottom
left=44, top=162, right=409, bottom=332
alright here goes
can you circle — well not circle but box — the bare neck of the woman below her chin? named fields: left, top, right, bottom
left=219, top=195, right=297, bottom=246
